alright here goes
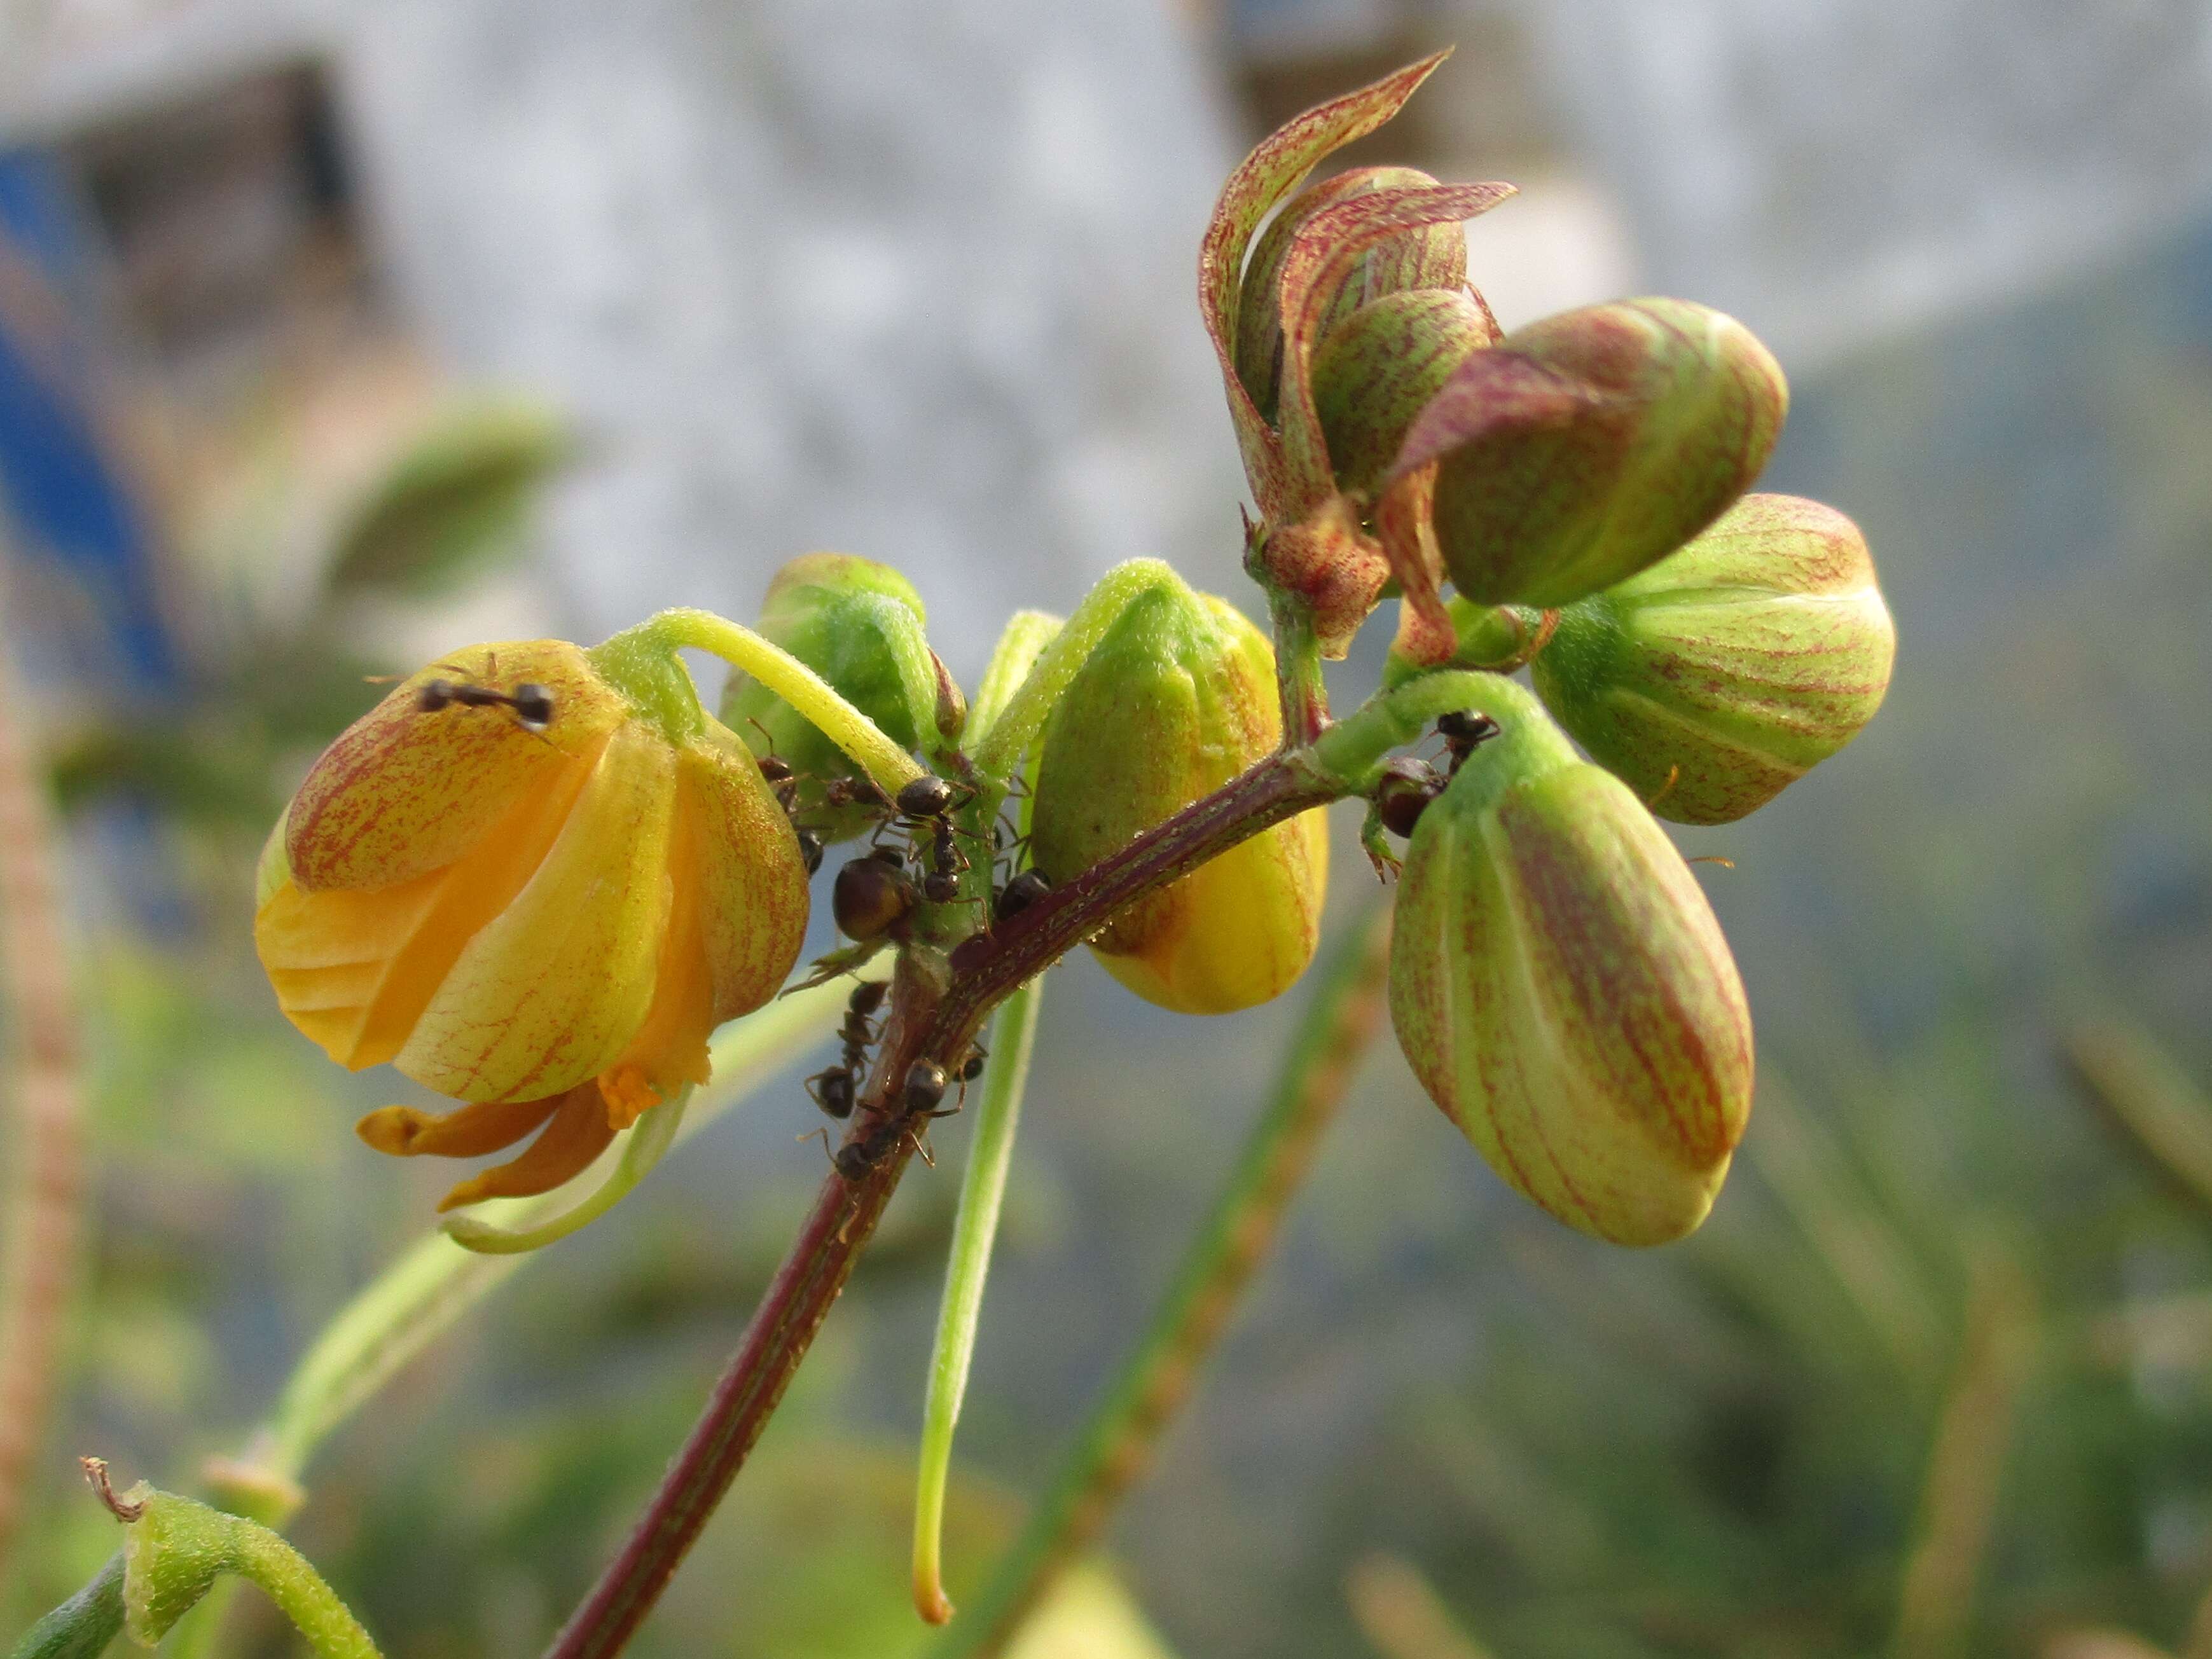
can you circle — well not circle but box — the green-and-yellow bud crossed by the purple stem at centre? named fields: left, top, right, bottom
left=1031, top=584, right=1329, bottom=1013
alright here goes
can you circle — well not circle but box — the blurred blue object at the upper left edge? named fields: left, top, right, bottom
left=0, top=151, right=177, bottom=692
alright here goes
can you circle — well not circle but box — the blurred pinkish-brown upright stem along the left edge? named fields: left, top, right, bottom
left=0, top=593, right=82, bottom=1568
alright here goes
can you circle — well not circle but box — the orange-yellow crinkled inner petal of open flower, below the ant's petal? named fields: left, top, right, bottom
left=254, top=761, right=593, bottom=1071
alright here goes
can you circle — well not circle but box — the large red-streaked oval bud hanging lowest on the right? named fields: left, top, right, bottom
left=1389, top=701, right=1752, bottom=1245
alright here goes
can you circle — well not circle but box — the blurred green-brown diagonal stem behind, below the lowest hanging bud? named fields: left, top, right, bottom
left=929, top=909, right=1389, bottom=1659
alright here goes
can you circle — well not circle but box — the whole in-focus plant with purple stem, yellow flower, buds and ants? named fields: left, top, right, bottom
left=4, top=57, right=1893, bottom=1659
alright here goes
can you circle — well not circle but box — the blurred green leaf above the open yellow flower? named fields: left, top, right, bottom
left=328, top=403, right=575, bottom=597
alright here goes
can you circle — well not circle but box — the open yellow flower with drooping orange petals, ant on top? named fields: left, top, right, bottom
left=254, top=639, right=807, bottom=1208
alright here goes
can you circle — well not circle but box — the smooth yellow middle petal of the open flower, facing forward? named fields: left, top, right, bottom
left=394, top=721, right=675, bottom=1099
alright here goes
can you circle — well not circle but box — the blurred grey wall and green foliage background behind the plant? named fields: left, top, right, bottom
left=0, top=0, right=2212, bottom=1659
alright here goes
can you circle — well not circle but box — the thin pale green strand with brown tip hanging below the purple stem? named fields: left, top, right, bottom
left=913, top=978, right=1044, bottom=1623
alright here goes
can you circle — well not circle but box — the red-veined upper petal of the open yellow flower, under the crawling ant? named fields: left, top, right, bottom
left=286, top=639, right=628, bottom=891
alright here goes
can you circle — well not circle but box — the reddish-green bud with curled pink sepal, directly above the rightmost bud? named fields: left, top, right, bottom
left=1392, top=299, right=1790, bottom=606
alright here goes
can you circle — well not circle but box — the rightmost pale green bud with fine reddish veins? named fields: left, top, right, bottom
left=1533, top=495, right=1898, bottom=823
